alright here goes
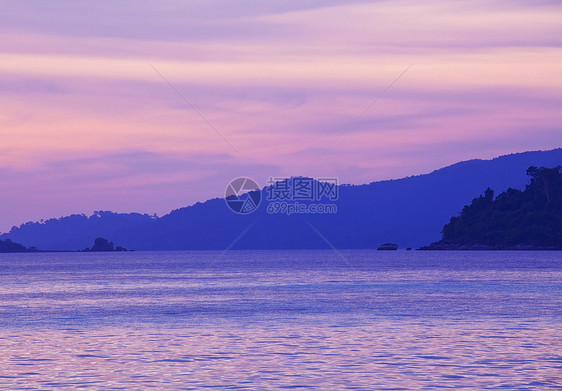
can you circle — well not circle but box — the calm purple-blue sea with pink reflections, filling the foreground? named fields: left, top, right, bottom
left=0, top=250, right=562, bottom=390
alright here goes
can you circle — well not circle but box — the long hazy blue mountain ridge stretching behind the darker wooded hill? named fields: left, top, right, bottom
left=0, top=149, right=562, bottom=250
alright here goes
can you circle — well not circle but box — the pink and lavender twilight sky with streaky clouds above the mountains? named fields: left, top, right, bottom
left=0, top=0, right=562, bottom=232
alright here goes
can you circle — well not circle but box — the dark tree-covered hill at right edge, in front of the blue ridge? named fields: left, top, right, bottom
left=424, top=166, right=562, bottom=250
